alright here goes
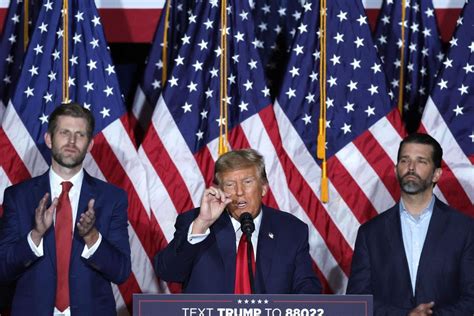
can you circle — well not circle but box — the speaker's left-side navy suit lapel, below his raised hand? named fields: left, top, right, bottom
left=213, top=211, right=237, bottom=293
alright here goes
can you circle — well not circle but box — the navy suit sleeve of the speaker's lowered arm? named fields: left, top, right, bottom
left=292, top=225, right=322, bottom=294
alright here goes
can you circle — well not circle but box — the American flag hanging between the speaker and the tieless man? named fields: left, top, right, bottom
left=270, top=0, right=403, bottom=293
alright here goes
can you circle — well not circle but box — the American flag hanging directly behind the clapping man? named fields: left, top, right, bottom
left=0, top=0, right=158, bottom=312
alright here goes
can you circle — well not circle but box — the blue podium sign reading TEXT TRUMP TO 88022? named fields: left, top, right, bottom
left=133, top=294, right=372, bottom=316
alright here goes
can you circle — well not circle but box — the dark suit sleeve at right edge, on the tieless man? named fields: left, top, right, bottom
left=433, top=219, right=474, bottom=316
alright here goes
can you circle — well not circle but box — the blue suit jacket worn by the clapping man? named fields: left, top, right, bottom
left=0, top=172, right=131, bottom=316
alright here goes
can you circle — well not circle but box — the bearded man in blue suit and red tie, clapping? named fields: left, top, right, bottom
left=0, top=103, right=131, bottom=316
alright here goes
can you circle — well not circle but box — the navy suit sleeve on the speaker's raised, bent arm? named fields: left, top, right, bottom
left=154, top=214, right=204, bottom=283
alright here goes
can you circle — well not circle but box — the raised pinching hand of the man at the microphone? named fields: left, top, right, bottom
left=192, top=187, right=232, bottom=234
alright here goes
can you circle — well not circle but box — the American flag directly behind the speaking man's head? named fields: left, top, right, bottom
left=135, top=0, right=286, bottom=292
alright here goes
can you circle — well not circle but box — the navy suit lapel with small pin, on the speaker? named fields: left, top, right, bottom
left=255, top=206, right=278, bottom=293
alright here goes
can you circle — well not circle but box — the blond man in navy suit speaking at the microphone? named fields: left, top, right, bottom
left=155, top=149, right=321, bottom=293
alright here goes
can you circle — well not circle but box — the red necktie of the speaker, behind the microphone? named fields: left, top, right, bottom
left=234, top=234, right=255, bottom=294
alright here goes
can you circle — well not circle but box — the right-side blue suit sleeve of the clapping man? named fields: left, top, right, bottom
left=82, top=190, right=131, bottom=284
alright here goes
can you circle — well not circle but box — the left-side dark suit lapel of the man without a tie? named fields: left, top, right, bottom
left=385, top=203, right=413, bottom=293
